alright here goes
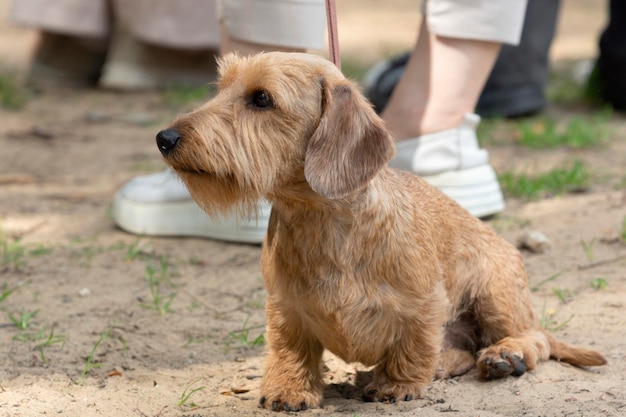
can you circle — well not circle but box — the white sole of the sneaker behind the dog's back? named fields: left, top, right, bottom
left=422, top=165, right=504, bottom=218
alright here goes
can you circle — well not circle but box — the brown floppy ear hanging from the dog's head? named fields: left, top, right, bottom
left=304, top=80, right=395, bottom=199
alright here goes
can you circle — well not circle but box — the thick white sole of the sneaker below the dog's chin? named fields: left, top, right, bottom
left=113, top=193, right=271, bottom=244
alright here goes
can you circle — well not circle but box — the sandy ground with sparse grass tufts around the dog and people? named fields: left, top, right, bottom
left=0, top=0, right=626, bottom=417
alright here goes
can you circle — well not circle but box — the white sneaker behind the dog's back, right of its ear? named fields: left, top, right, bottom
left=389, top=113, right=504, bottom=217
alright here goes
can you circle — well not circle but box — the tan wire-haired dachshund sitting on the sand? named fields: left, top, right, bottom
left=157, top=53, right=606, bottom=410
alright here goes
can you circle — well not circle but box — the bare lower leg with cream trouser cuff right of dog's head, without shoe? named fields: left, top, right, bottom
left=382, top=0, right=526, bottom=136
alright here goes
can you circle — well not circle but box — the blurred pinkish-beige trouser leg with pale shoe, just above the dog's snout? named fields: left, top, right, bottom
left=100, top=0, right=219, bottom=90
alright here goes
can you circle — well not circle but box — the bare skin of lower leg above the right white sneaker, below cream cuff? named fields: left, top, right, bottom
left=382, top=22, right=500, bottom=140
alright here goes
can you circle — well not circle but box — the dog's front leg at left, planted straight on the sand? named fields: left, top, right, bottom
left=259, top=300, right=324, bottom=411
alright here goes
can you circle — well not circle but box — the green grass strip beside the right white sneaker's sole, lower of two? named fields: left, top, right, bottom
left=498, top=160, right=591, bottom=200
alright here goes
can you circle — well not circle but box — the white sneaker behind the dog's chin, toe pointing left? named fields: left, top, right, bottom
left=113, top=169, right=271, bottom=244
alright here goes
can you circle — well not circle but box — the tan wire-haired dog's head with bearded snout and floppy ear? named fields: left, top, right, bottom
left=157, top=52, right=394, bottom=213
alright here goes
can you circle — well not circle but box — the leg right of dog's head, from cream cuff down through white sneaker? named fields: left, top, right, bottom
left=382, top=0, right=525, bottom=217
